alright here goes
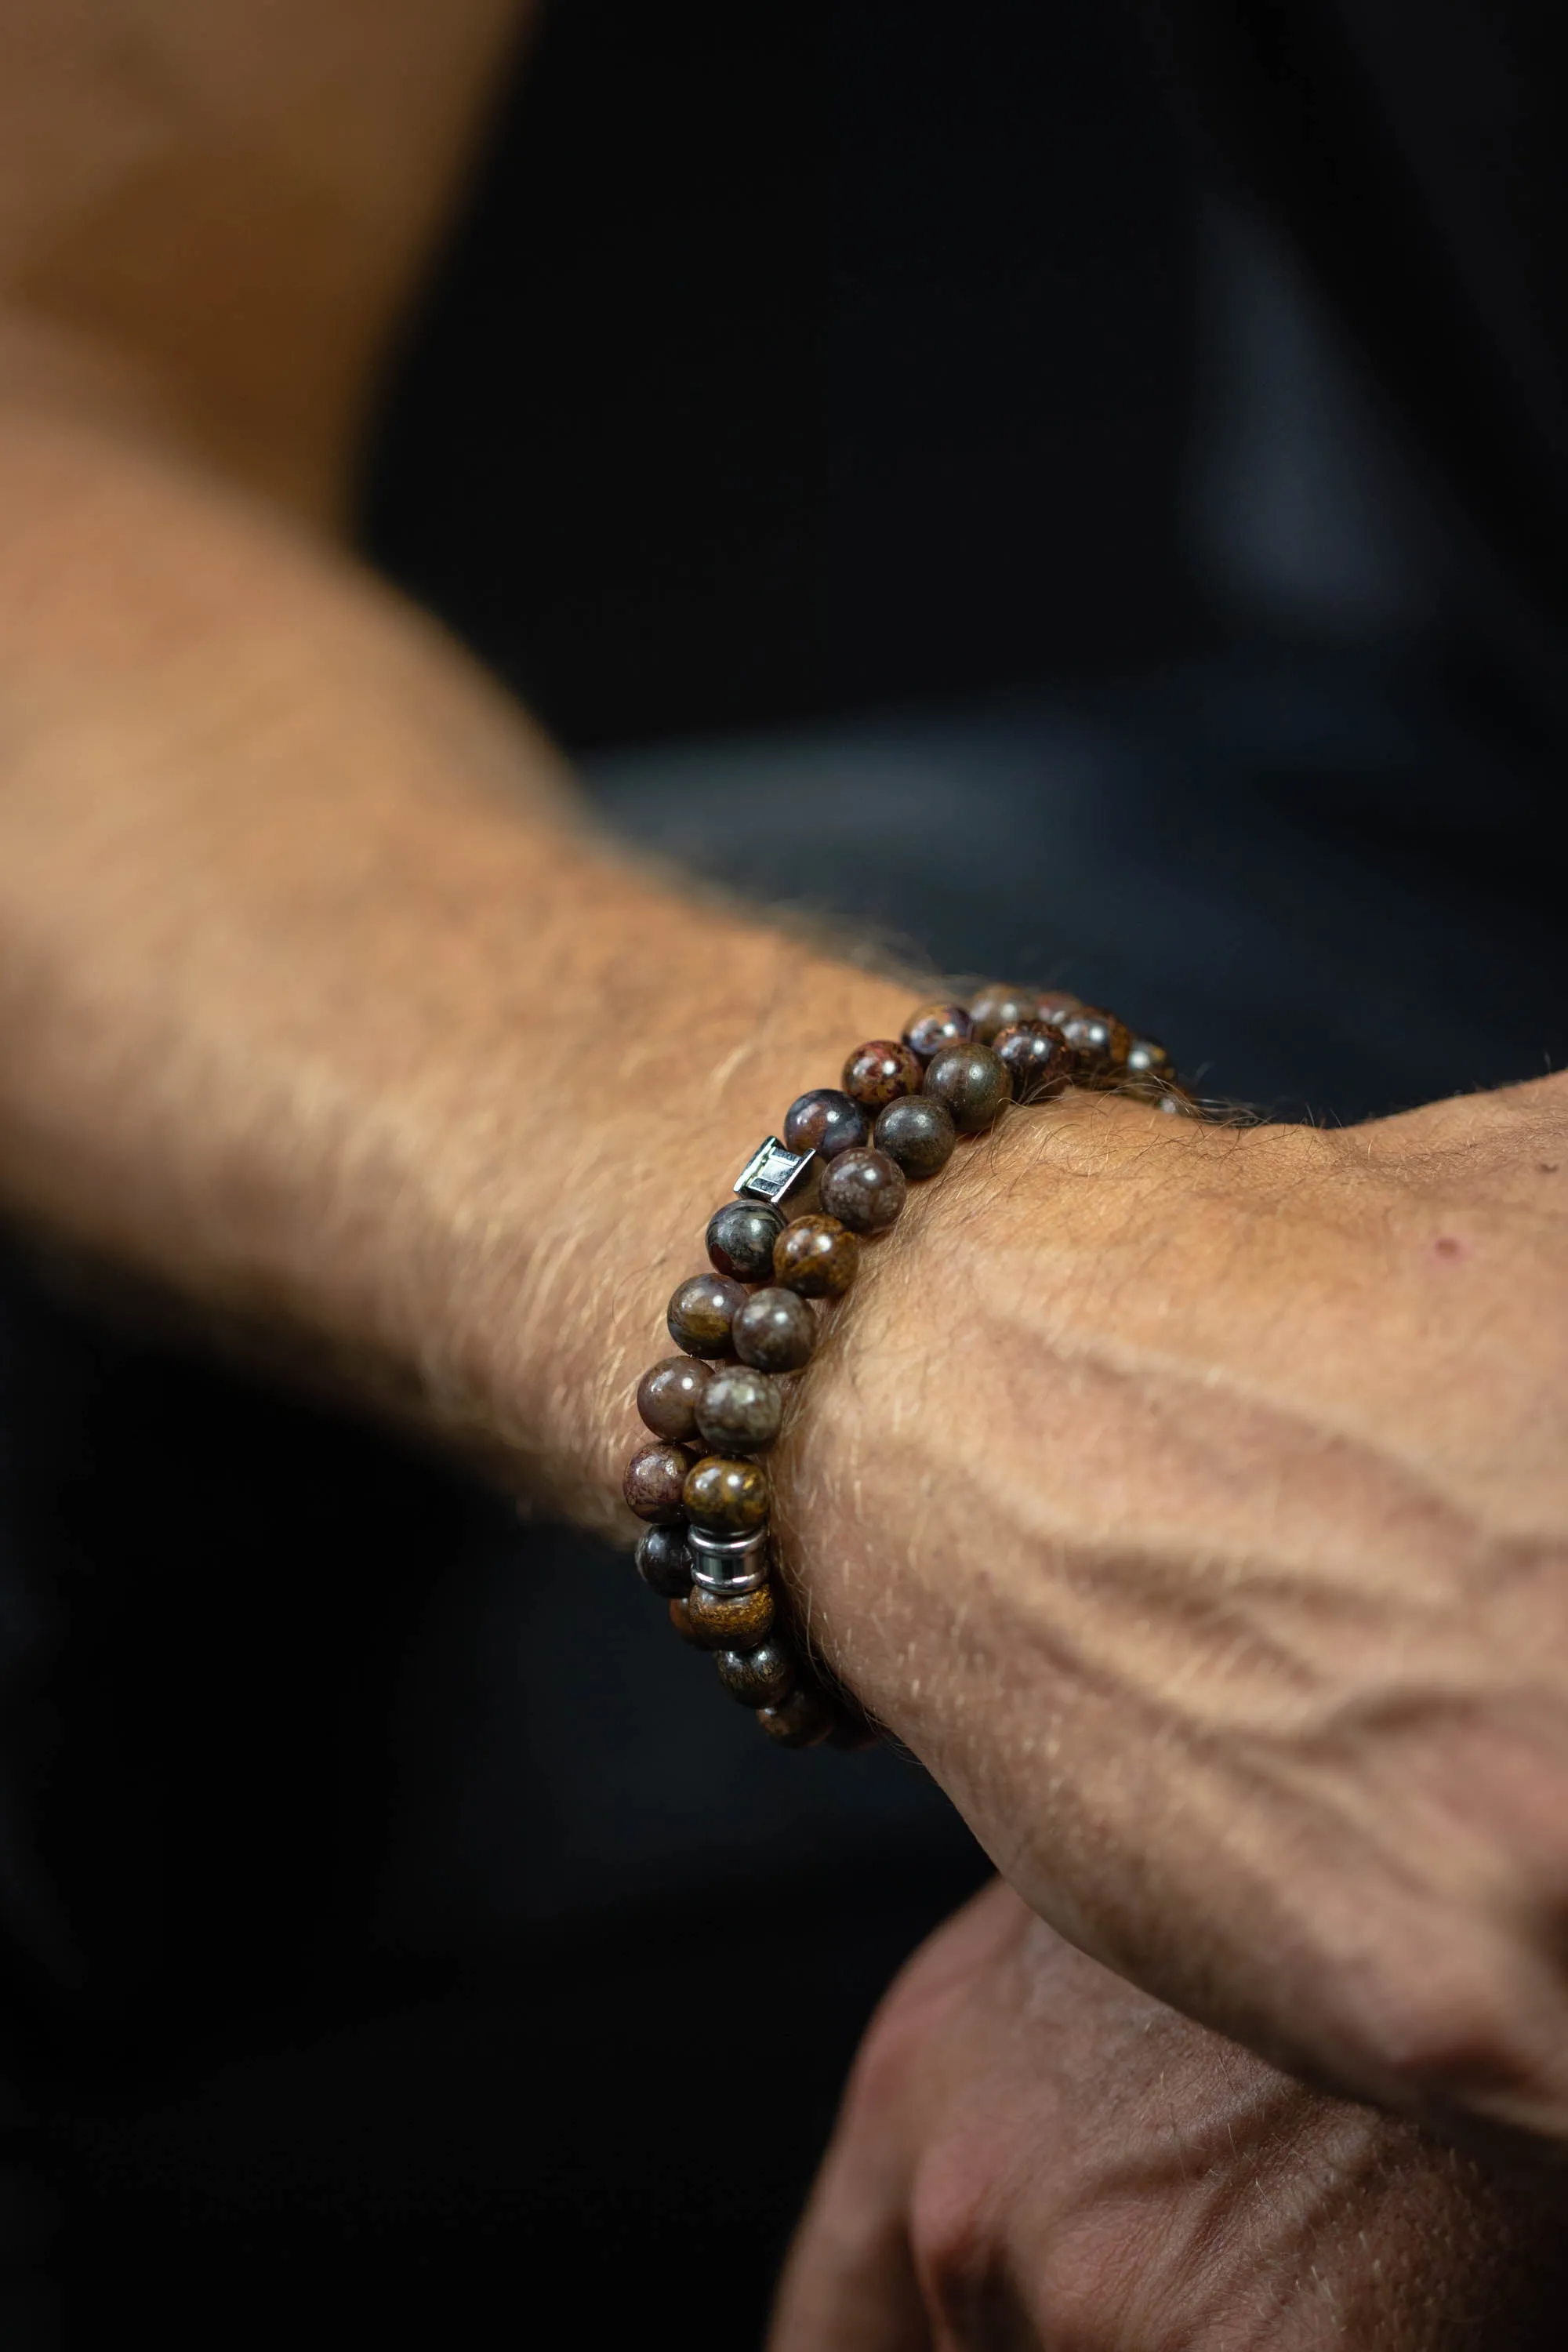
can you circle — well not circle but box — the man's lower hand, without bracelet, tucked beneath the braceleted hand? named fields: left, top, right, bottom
left=771, top=1884, right=1566, bottom=2352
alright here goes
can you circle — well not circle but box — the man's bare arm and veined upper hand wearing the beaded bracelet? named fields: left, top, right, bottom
left=0, top=0, right=1568, bottom=2239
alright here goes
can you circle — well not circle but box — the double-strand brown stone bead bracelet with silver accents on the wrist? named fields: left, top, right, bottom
left=623, top=988, right=1199, bottom=1748
